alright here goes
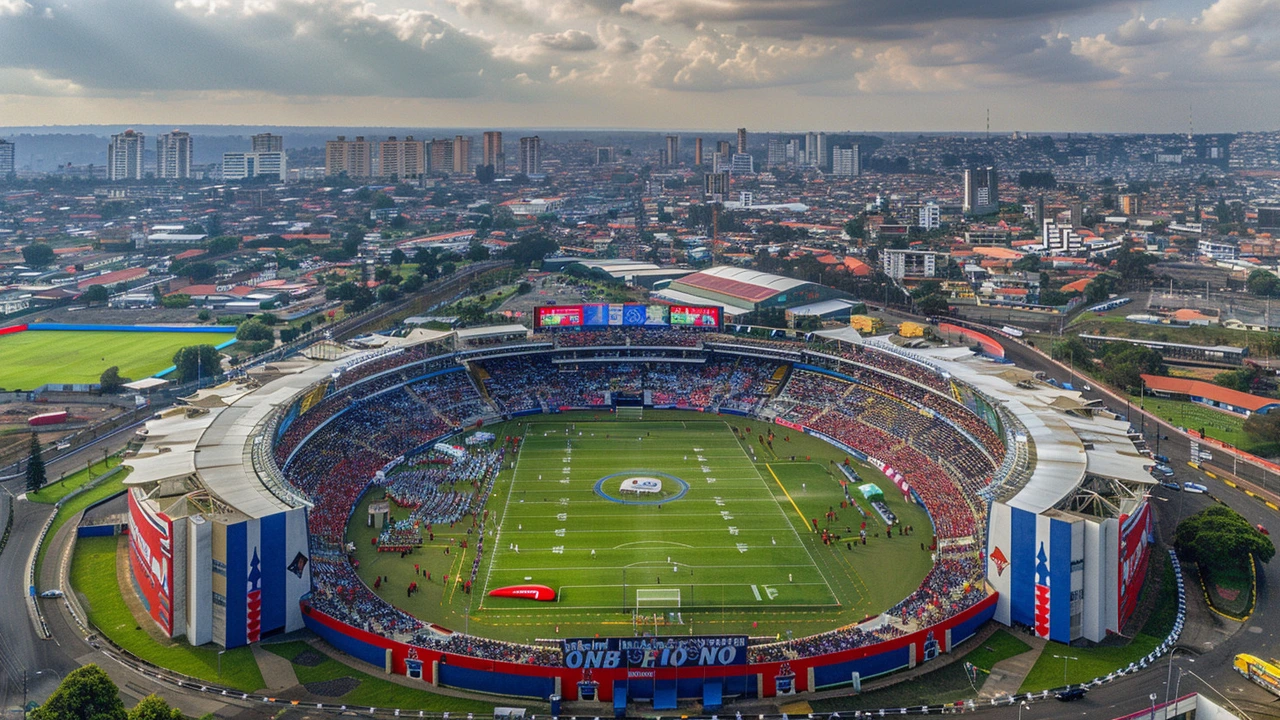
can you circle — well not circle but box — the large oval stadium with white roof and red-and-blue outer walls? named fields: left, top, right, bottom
left=127, top=299, right=1153, bottom=710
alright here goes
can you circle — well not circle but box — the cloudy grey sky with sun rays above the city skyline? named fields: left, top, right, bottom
left=0, top=0, right=1280, bottom=132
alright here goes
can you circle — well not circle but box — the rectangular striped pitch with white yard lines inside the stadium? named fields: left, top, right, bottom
left=483, top=421, right=840, bottom=612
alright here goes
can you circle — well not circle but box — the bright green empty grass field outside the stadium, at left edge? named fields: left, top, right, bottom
left=0, top=331, right=225, bottom=391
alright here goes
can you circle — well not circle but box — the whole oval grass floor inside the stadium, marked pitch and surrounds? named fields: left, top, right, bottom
left=348, top=410, right=932, bottom=642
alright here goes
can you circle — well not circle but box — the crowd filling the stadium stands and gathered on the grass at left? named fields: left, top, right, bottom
left=275, top=328, right=1004, bottom=665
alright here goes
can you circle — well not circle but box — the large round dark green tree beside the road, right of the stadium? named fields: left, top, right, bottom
left=1174, top=505, right=1276, bottom=573
